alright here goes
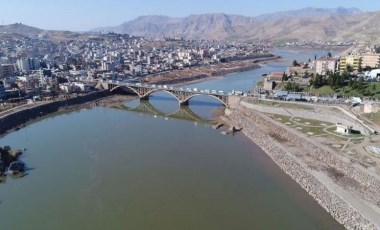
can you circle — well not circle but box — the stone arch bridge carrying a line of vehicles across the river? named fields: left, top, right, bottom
left=102, top=83, right=229, bottom=107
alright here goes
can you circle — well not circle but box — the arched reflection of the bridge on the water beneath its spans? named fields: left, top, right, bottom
left=118, top=95, right=221, bottom=124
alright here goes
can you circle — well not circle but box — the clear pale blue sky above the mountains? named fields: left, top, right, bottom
left=0, top=0, right=380, bottom=31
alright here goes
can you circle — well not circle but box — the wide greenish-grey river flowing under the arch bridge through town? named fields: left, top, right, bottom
left=0, top=48, right=343, bottom=230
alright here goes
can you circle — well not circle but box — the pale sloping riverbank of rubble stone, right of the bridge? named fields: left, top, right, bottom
left=227, top=99, right=380, bottom=229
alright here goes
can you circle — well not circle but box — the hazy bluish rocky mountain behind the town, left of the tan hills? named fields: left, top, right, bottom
left=93, top=14, right=254, bottom=39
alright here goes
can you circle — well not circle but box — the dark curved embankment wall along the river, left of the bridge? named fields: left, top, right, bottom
left=0, top=91, right=110, bottom=135
